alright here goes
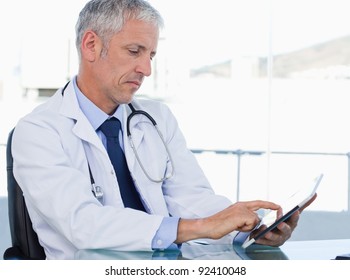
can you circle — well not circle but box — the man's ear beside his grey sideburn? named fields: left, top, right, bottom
left=81, top=30, right=102, bottom=62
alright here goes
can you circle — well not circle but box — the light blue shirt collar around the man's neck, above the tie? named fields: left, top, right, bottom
left=73, top=76, right=124, bottom=130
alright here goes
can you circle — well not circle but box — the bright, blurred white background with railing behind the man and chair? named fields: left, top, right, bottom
left=0, top=0, right=350, bottom=258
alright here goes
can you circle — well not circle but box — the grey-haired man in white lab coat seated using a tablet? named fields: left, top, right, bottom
left=12, top=0, right=308, bottom=259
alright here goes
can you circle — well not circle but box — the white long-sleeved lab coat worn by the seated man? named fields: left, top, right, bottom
left=12, top=83, right=231, bottom=259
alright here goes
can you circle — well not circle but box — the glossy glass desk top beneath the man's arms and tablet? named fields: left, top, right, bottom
left=76, top=239, right=350, bottom=260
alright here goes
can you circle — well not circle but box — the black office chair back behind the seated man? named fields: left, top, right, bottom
left=4, top=129, right=46, bottom=260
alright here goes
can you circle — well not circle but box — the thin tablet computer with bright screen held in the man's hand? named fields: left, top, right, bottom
left=242, top=174, right=323, bottom=248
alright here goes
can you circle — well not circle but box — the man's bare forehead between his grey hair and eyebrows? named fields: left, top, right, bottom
left=111, top=19, right=159, bottom=50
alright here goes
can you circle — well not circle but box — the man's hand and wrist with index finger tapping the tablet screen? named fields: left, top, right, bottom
left=175, top=200, right=281, bottom=243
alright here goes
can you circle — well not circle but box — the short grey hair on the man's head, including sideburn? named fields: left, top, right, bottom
left=75, top=0, right=163, bottom=59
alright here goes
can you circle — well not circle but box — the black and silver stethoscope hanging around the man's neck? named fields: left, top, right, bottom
left=62, top=82, right=174, bottom=202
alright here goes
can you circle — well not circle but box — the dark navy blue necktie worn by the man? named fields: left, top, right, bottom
left=99, top=118, right=145, bottom=211
